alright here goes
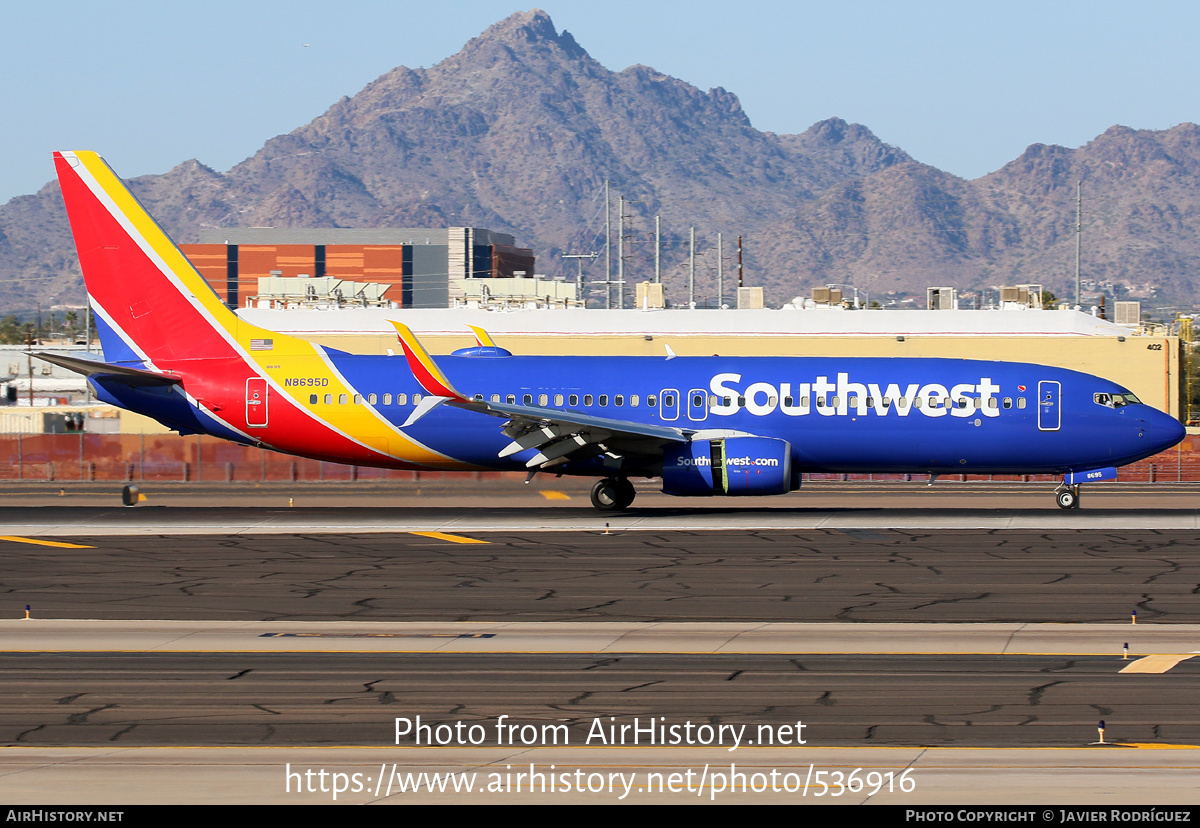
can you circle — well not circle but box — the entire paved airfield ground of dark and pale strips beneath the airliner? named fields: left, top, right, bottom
left=0, top=492, right=1200, bottom=805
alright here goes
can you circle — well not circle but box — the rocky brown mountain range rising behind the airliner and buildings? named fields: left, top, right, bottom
left=0, top=11, right=1200, bottom=307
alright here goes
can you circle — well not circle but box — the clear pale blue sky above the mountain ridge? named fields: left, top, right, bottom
left=0, top=0, right=1200, bottom=203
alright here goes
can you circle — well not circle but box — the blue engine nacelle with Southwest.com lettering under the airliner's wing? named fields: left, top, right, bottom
left=662, top=437, right=793, bottom=497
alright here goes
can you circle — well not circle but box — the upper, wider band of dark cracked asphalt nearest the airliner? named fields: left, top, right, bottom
left=7, top=528, right=1200, bottom=624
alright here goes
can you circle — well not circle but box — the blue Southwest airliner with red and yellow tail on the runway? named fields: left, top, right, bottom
left=43, top=152, right=1184, bottom=510
